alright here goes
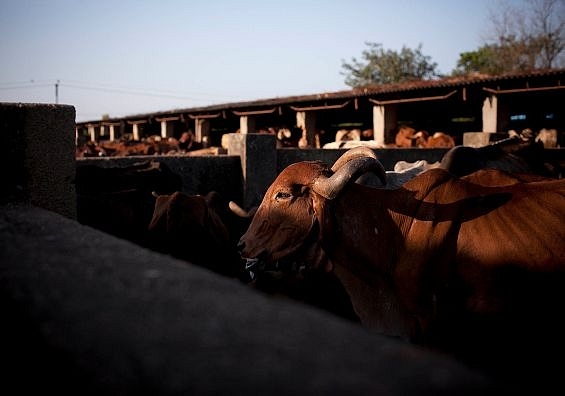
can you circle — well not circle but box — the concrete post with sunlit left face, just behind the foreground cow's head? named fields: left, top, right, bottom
left=227, top=133, right=277, bottom=210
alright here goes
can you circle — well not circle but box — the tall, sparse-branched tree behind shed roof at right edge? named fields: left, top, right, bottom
left=453, top=0, right=565, bottom=75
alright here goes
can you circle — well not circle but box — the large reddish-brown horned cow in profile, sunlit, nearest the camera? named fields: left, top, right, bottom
left=239, top=148, right=565, bottom=375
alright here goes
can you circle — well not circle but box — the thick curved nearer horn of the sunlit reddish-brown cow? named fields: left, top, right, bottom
left=312, top=156, right=386, bottom=199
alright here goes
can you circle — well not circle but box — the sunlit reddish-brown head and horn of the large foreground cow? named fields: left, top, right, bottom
left=239, top=156, right=386, bottom=270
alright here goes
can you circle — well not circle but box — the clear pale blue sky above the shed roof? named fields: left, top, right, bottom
left=0, top=0, right=519, bottom=122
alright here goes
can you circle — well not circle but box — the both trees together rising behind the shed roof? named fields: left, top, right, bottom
left=341, top=0, right=565, bottom=88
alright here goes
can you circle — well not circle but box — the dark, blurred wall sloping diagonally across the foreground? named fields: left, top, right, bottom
left=0, top=204, right=500, bottom=395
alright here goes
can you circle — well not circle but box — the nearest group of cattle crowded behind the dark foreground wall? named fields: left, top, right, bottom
left=77, top=136, right=565, bottom=390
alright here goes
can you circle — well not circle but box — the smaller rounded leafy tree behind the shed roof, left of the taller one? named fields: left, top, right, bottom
left=341, top=42, right=439, bottom=88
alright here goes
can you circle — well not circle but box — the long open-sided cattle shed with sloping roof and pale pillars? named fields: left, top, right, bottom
left=76, top=69, right=565, bottom=147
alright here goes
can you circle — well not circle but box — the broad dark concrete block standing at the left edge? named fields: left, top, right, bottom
left=0, top=103, right=76, bottom=219
